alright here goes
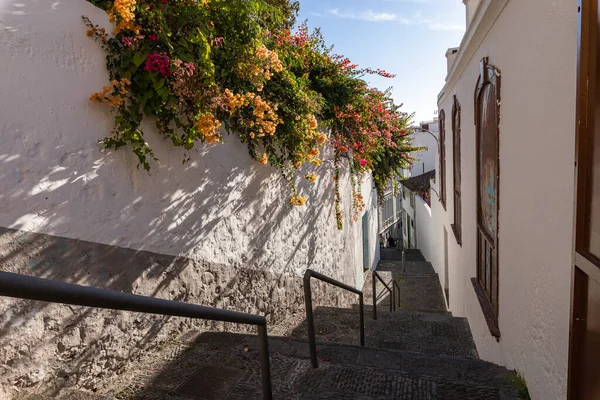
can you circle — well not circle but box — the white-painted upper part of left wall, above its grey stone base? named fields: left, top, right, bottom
left=0, top=0, right=375, bottom=286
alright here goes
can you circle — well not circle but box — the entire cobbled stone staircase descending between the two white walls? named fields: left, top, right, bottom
left=16, top=250, right=518, bottom=400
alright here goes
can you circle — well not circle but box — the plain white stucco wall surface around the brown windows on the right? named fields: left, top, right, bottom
left=431, top=0, right=577, bottom=400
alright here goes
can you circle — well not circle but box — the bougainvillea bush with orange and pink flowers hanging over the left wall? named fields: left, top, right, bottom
left=83, top=0, right=418, bottom=229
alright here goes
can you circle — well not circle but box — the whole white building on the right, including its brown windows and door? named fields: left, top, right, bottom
left=418, top=0, right=600, bottom=400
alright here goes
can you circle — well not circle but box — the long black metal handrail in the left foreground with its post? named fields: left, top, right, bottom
left=0, top=271, right=273, bottom=400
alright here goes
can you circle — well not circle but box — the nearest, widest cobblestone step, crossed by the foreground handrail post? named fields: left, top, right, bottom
left=98, top=332, right=517, bottom=400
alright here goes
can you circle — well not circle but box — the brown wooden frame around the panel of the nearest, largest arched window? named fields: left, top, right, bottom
left=471, top=57, right=501, bottom=341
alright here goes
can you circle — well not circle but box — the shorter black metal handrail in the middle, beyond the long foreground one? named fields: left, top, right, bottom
left=304, top=269, right=365, bottom=368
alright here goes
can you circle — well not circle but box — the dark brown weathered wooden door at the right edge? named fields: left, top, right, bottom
left=569, top=0, right=600, bottom=400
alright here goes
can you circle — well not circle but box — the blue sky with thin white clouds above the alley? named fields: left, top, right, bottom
left=298, top=0, right=465, bottom=122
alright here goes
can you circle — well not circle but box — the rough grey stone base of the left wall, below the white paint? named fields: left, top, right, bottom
left=0, top=228, right=355, bottom=398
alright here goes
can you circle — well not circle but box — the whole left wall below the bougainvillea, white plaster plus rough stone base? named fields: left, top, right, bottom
left=0, top=0, right=378, bottom=397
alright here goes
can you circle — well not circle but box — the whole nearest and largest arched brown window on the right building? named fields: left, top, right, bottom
left=474, top=57, right=500, bottom=338
